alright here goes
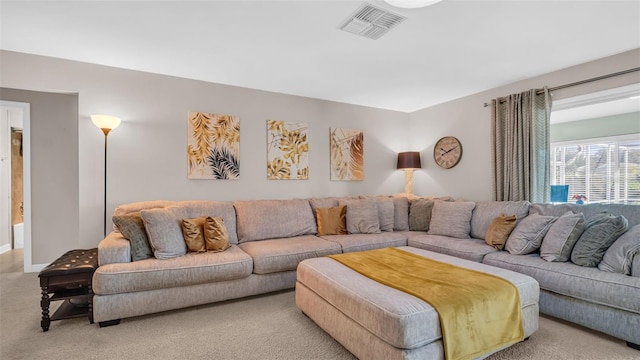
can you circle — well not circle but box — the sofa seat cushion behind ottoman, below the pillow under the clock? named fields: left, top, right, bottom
left=408, top=235, right=499, bottom=262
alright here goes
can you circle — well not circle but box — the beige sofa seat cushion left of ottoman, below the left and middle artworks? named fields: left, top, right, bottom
left=238, top=235, right=341, bottom=274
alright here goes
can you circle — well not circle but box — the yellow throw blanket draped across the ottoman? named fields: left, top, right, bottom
left=329, top=248, right=524, bottom=360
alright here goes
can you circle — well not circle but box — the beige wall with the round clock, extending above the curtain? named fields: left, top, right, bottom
left=409, top=49, right=640, bottom=200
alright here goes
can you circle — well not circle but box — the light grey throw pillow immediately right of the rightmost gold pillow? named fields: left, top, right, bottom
left=505, top=214, right=558, bottom=255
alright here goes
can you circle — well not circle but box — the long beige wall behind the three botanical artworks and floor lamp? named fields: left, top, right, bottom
left=0, top=51, right=409, bottom=264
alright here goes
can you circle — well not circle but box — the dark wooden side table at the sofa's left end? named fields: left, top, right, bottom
left=38, top=248, right=98, bottom=331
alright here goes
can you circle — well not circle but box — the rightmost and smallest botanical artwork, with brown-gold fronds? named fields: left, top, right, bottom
left=329, top=128, right=364, bottom=181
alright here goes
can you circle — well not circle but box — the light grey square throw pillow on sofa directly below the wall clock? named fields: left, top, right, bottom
left=427, top=201, right=476, bottom=239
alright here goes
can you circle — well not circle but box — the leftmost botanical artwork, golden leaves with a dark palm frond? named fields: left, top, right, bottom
left=187, top=112, right=240, bottom=179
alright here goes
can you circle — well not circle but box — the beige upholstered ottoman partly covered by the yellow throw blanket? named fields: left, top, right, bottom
left=296, top=247, right=540, bottom=360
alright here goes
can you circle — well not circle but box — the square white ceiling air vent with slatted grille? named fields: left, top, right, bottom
left=338, top=3, right=407, bottom=40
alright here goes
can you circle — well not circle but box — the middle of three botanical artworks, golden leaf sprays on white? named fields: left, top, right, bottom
left=267, top=120, right=309, bottom=180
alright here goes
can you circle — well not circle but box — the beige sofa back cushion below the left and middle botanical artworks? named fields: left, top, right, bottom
left=234, top=199, right=317, bottom=243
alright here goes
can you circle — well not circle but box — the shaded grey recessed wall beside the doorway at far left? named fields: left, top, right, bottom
left=0, top=88, right=80, bottom=264
